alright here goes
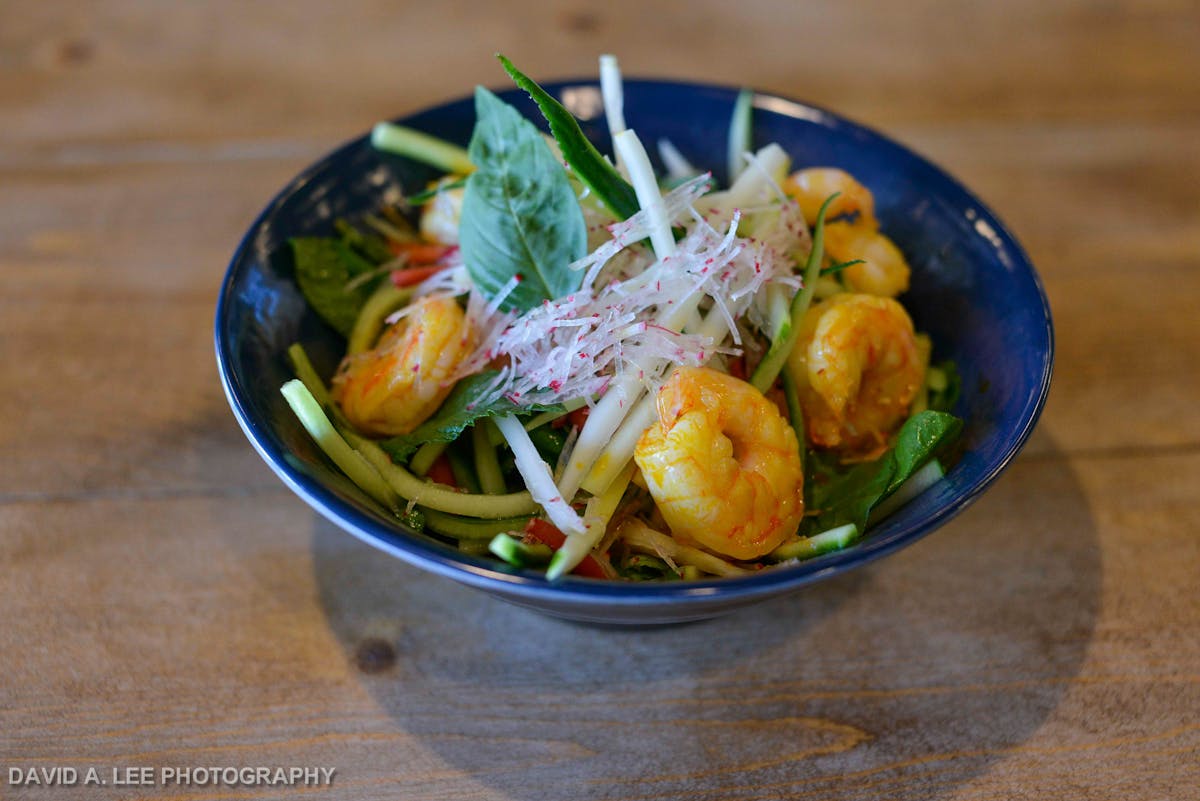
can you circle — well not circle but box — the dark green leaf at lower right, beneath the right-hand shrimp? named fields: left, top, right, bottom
left=809, top=411, right=962, bottom=531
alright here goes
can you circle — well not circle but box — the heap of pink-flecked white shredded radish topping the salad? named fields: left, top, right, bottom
left=458, top=169, right=803, bottom=405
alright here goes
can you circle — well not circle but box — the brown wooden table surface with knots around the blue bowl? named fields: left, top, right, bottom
left=0, top=0, right=1200, bottom=801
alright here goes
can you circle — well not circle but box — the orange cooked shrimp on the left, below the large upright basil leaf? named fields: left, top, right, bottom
left=334, top=296, right=475, bottom=436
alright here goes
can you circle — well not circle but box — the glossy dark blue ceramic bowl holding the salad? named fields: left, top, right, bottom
left=216, top=80, right=1054, bottom=624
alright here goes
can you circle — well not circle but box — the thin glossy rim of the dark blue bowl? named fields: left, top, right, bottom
left=214, top=77, right=1055, bottom=607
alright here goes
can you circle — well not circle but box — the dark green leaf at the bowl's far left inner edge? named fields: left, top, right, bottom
left=290, top=237, right=376, bottom=337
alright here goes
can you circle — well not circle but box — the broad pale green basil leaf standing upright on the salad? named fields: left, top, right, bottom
left=458, top=86, right=587, bottom=311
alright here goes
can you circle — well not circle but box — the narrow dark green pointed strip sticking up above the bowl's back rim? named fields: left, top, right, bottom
left=497, top=55, right=641, bottom=219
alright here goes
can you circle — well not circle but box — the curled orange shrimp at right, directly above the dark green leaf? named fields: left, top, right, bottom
left=788, top=293, right=925, bottom=457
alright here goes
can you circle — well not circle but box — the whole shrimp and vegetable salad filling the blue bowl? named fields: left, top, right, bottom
left=282, top=56, right=961, bottom=580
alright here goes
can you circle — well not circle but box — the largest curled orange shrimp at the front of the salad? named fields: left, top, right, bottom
left=634, top=367, right=804, bottom=559
